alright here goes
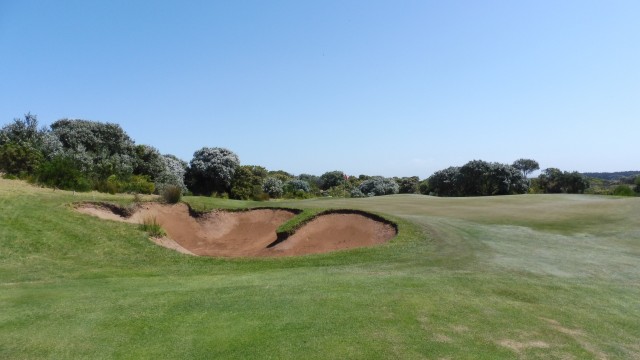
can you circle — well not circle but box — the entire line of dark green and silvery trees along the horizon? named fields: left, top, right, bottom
left=0, top=114, right=604, bottom=200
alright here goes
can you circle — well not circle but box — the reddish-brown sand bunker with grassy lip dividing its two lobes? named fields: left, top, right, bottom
left=76, top=203, right=396, bottom=257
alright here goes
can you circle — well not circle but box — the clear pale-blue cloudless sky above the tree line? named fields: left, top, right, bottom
left=0, top=0, right=640, bottom=178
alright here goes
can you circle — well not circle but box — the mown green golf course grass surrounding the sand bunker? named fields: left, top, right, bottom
left=0, top=180, right=640, bottom=359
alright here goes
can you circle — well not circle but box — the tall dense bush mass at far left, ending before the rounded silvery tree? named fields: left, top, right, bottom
left=0, top=114, right=195, bottom=193
